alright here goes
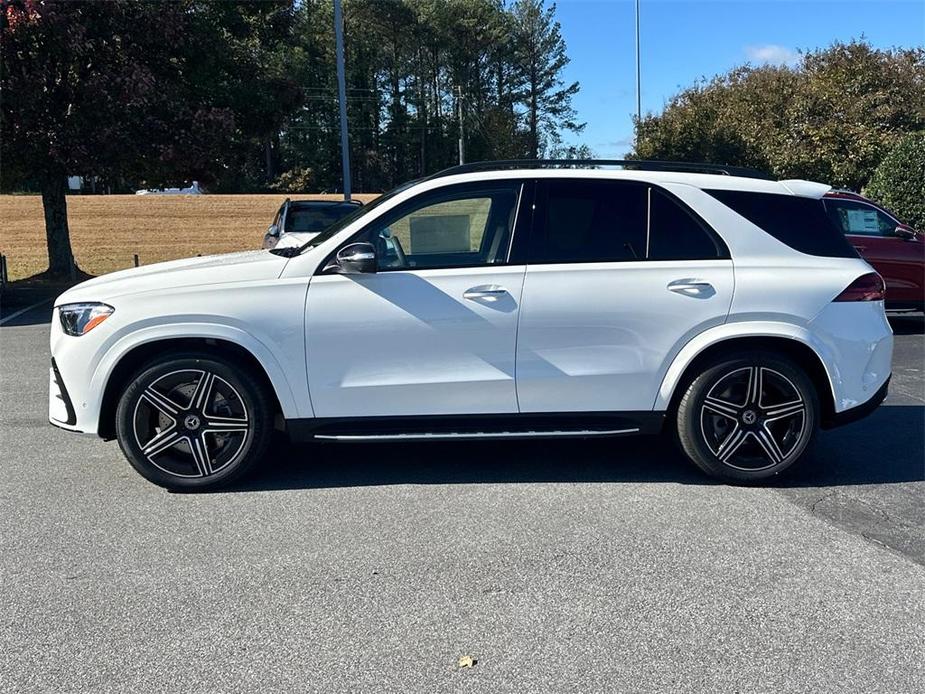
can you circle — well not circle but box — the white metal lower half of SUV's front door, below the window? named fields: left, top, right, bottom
left=306, top=265, right=525, bottom=417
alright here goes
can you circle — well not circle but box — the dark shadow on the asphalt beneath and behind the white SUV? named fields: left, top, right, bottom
left=223, top=406, right=925, bottom=491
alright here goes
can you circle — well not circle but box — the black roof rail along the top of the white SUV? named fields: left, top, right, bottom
left=427, top=159, right=775, bottom=181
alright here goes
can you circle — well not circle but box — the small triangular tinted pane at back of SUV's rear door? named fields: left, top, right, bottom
left=648, top=188, right=728, bottom=260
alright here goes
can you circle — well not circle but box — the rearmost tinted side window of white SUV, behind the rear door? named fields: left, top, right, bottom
left=706, top=190, right=858, bottom=258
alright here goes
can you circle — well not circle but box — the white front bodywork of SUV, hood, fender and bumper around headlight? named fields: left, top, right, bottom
left=51, top=251, right=312, bottom=432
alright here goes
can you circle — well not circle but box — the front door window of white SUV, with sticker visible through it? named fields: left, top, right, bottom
left=353, top=181, right=521, bottom=270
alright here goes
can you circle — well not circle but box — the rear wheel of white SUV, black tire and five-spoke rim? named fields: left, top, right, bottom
left=676, top=352, right=819, bottom=483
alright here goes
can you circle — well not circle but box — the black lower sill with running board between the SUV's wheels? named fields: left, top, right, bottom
left=286, top=412, right=665, bottom=441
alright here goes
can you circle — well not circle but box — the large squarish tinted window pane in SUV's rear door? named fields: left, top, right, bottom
left=530, top=179, right=647, bottom=263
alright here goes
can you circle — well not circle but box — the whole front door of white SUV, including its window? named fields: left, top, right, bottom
left=306, top=181, right=525, bottom=417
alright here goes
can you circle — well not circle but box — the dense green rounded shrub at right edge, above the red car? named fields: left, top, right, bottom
left=864, top=132, right=925, bottom=232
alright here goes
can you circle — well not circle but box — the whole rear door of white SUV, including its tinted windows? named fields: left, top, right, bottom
left=517, top=178, right=733, bottom=412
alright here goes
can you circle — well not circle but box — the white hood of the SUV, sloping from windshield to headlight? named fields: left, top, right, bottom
left=55, top=251, right=288, bottom=306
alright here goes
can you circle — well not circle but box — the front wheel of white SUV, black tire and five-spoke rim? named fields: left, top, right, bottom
left=116, top=353, right=274, bottom=490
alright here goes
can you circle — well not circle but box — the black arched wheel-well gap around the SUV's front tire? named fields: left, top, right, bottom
left=97, top=337, right=284, bottom=439
